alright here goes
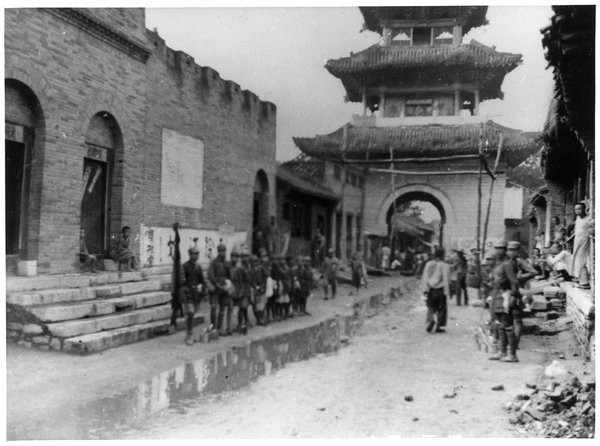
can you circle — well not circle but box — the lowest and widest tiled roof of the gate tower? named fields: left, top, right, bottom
left=294, top=121, right=540, bottom=166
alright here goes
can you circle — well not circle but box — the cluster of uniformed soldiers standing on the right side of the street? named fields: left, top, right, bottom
left=481, top=241, right=538, bottom=362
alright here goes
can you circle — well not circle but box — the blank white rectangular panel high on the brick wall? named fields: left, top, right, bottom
left=160, top=129, right=204, bottom=209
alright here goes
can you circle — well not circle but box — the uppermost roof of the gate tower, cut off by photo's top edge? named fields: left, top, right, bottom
left=359, top=6, right=488, bottom=34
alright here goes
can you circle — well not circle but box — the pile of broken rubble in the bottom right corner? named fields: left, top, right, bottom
left=504, top=375, right=596, bottom=438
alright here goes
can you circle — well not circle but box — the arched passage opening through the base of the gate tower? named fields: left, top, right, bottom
left=386, top=191, right=446, bottom=253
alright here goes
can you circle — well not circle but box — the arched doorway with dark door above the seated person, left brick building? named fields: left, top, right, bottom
left=81, top=112, right=123, bottom=255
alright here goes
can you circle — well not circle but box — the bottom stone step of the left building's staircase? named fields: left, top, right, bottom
left=61, top=314, right=204, bottom=354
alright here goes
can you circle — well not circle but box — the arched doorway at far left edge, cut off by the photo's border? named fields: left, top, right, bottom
left=4, top=79, right=45, bottom=260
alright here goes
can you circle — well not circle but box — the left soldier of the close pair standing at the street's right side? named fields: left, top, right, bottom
left=489, top=241, right=520, bottom=362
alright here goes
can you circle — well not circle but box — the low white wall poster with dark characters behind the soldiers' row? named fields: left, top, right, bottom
left=140, top=225, right=249, bottom=268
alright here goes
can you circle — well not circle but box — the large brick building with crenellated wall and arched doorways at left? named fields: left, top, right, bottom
left=4, top=8, right=276, bottom=273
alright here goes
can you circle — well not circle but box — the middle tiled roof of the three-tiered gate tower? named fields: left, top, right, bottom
left=325, top=40, right=521, bottom=77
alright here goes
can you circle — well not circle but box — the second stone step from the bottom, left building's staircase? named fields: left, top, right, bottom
left=46, top=304, right=171, bottom=338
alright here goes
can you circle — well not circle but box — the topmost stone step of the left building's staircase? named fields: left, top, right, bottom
left=6, top=271, right=145, bottom=294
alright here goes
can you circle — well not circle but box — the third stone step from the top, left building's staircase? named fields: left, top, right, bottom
left=27, top=291, right=171, bottom=323
